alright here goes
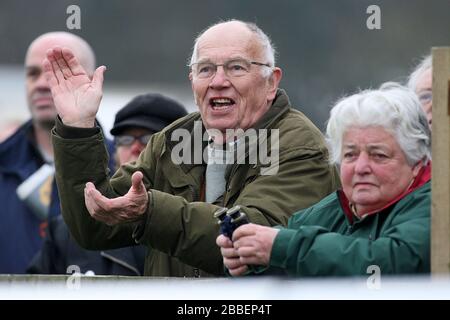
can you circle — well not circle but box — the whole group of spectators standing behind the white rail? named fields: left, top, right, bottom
left=0, top=20, right=433, bottom=277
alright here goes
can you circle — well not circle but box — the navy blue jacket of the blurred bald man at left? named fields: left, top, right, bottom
left=0, top=120, right=114, bottom=273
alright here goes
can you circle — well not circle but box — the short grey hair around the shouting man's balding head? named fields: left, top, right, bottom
left=189, top=19, right=276, bottom=77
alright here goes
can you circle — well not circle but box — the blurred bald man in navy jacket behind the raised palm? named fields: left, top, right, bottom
left=0, top=32, right=113, bottom=273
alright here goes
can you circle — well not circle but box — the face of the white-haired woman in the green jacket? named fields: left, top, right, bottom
left=341, top=126, right=421, bottom=215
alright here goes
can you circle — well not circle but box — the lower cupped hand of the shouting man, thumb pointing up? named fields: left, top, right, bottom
left=84, top=171, right=149, bottom=226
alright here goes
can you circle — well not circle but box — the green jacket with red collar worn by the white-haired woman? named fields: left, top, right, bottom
left=270, top=166, right=431, bottom=276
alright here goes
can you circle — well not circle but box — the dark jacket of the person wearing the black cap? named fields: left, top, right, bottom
left=27, top=215, right=145, bottom=276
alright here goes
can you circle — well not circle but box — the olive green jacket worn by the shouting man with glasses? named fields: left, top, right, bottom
left=53, top=90, right=339, bottom=277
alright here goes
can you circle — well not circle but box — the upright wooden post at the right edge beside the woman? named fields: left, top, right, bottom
left=431, top=47, right=450, bottom=275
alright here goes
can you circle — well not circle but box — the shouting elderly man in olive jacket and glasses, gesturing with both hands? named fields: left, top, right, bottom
left=43, top=21, right=338, bottom=277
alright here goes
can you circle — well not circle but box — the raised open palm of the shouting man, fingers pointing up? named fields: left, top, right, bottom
left=42, top=47, right=106, bottom=128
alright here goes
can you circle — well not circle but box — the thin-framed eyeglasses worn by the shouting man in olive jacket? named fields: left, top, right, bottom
left=189, top=59, right=270, bottom=79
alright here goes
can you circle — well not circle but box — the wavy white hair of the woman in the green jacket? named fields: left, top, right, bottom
left=326, top=82, right=431, bottom=166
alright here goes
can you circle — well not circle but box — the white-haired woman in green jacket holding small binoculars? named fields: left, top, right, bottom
left=217, top=83, right=431, bottom=276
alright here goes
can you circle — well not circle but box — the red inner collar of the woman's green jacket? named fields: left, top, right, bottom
left=337, top=162, right=431, bottom=224
